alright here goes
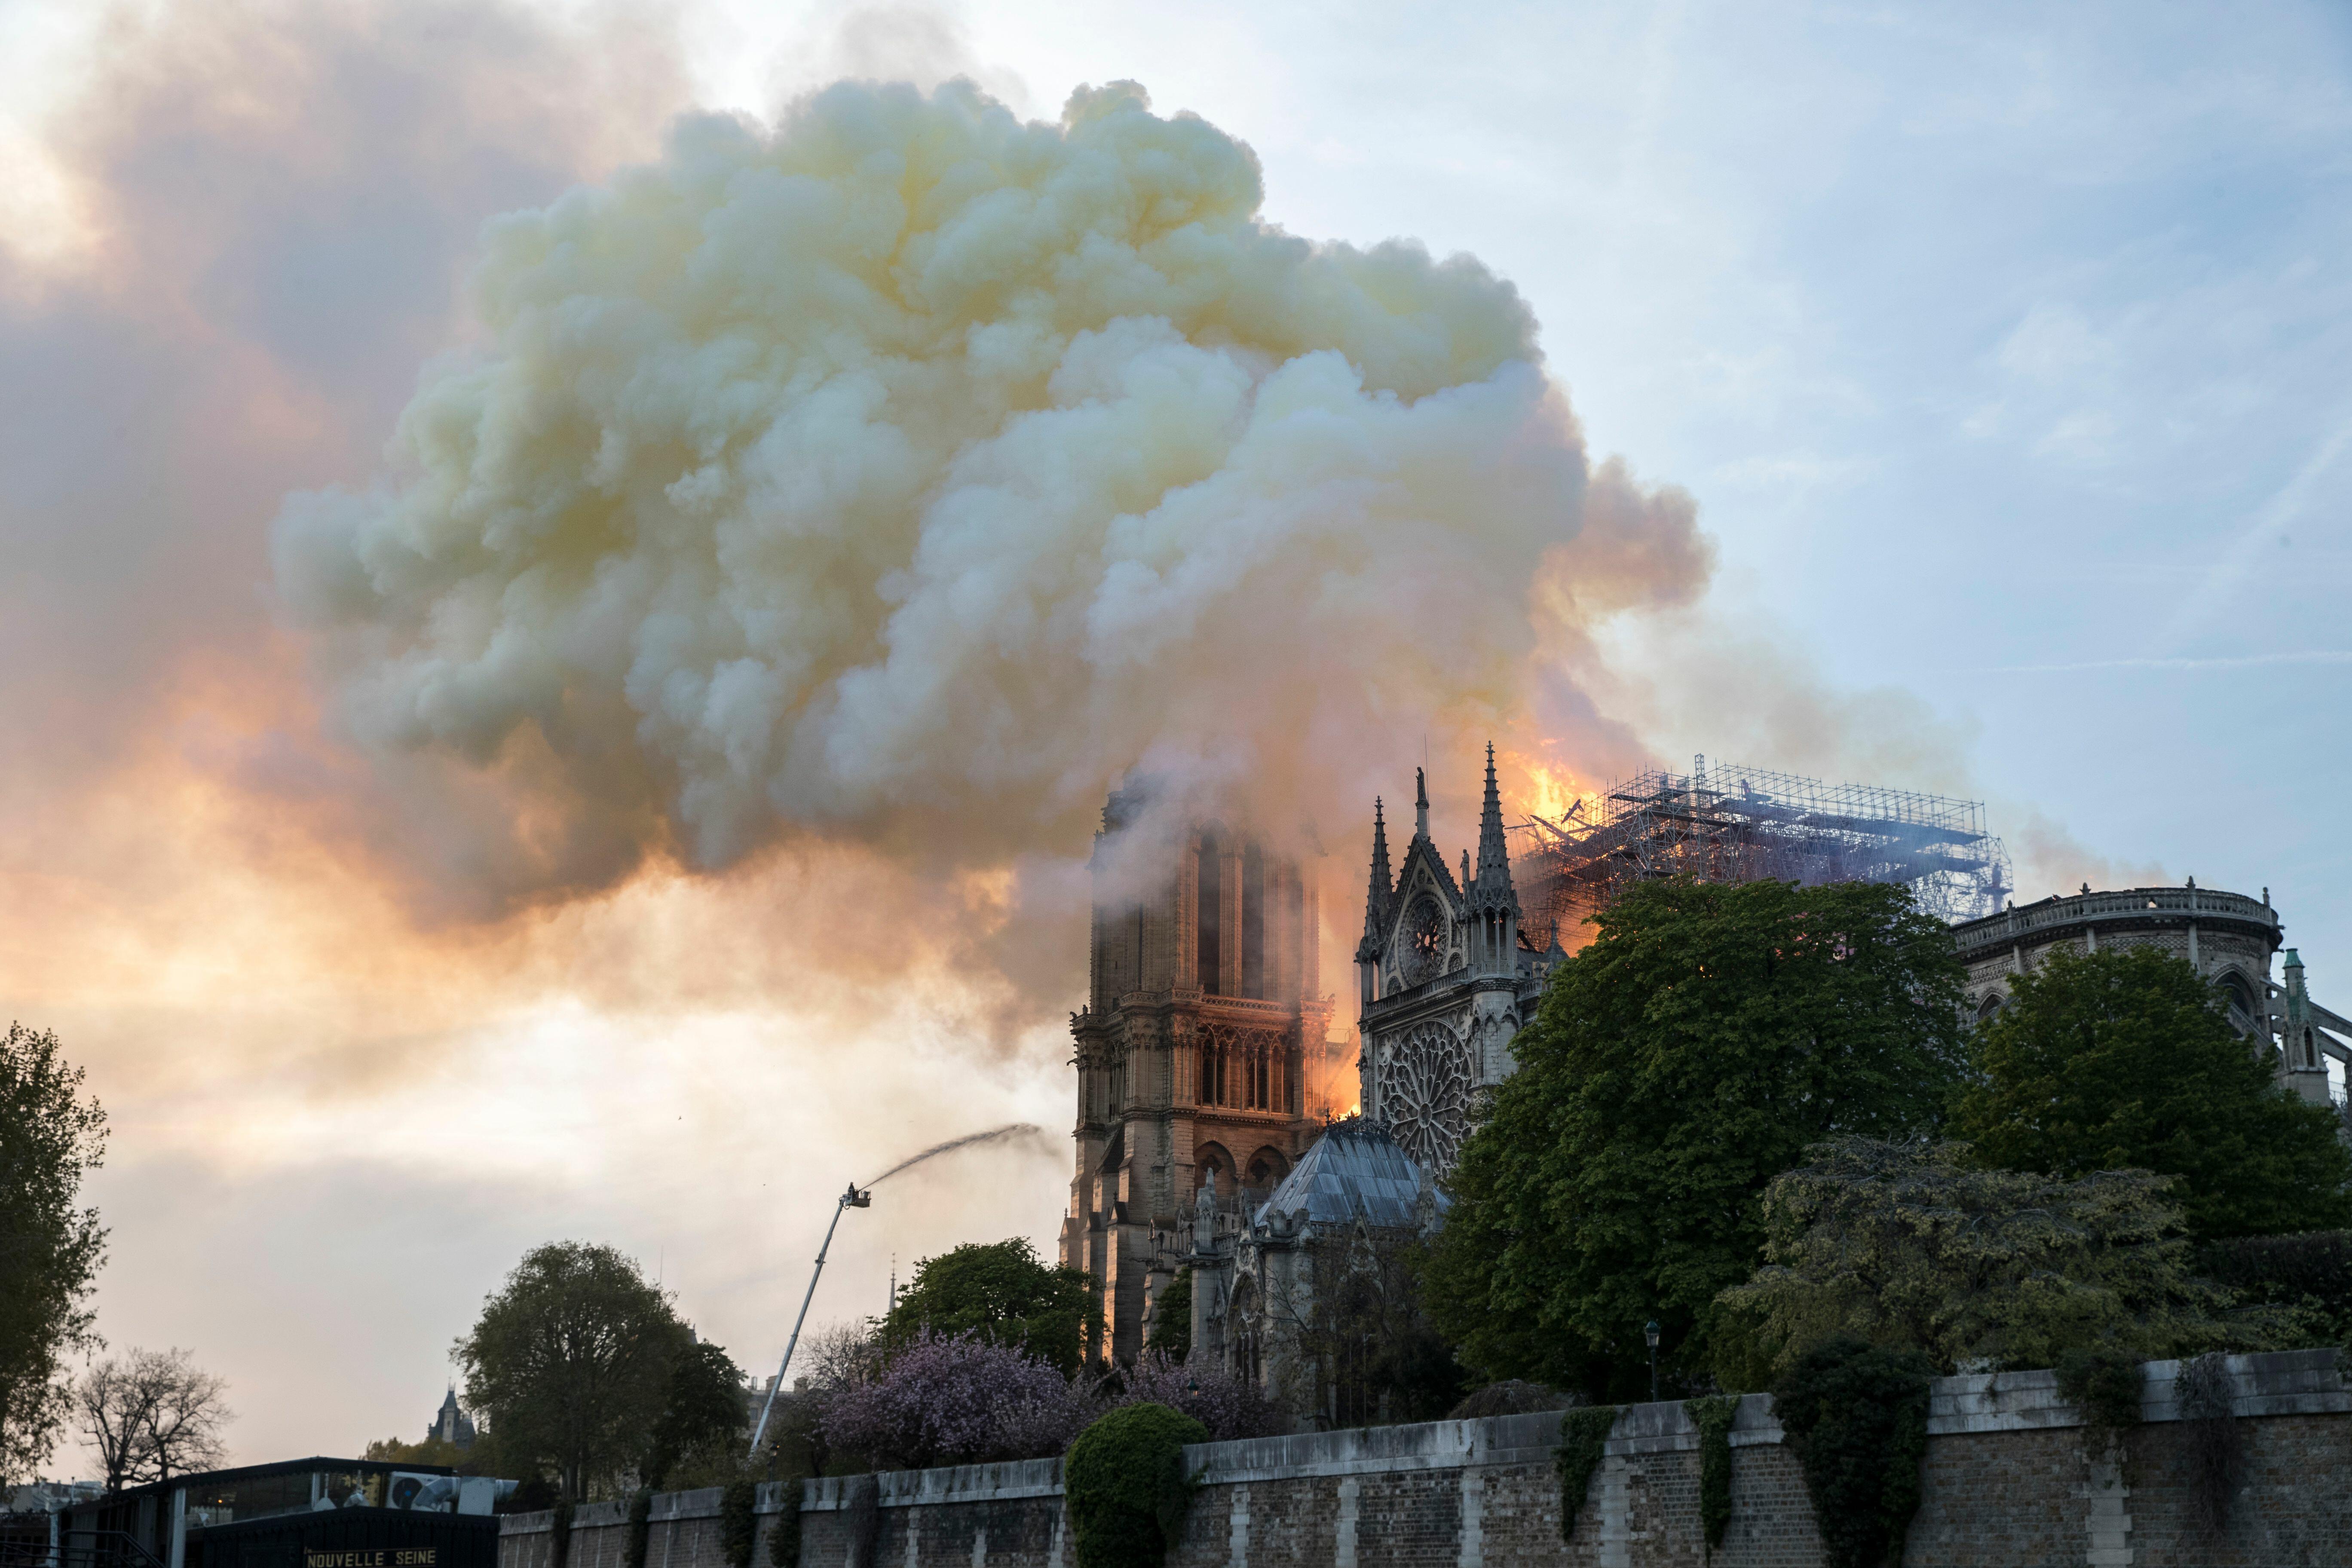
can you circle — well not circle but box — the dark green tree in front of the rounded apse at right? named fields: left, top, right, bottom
left=1954, top=947, right=2352, bottom=1239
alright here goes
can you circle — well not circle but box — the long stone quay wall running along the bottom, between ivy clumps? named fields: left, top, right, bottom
left=499, top=1352, right=2352, bottom=1568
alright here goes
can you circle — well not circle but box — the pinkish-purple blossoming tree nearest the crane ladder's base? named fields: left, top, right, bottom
left=821, top=1328, right=1098, bottom=1469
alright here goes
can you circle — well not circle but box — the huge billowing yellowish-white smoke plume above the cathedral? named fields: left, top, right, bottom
left=275, top=82, right=1705, bottom=898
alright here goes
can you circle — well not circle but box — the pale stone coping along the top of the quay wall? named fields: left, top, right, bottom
left=524, top=1349, right=2352, bottom=1535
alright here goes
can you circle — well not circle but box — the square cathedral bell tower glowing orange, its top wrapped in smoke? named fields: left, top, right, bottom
left=1061, top=785, right=1331, bottom=1361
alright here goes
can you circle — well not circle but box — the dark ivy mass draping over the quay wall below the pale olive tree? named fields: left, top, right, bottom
left=1771, top=1338, right=1936, bottom=1568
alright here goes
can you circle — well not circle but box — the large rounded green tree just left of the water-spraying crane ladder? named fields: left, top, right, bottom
left=456, top=1241, right=687, bottom=1502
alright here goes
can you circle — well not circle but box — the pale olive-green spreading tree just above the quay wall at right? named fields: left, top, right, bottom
left=1715, top=1138, right=2269, bottom=1389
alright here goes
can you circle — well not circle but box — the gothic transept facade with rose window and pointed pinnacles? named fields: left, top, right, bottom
left=1355, top=745, right=1566, bottom=1176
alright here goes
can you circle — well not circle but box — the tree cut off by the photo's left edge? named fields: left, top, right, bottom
left=0, top=1023, right=106, bottom=1491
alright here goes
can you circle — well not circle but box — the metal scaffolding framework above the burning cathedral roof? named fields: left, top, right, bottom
left=1510, top=757, right=2011, bottom=947
